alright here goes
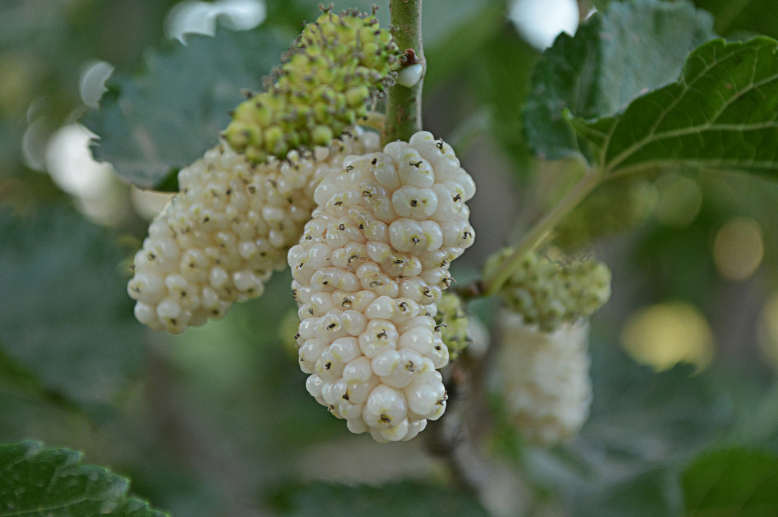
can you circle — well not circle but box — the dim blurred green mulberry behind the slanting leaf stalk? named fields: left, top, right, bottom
left=554, top=178, right=659, bottom=250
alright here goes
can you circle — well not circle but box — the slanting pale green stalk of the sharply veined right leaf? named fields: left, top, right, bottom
left=481, top=168, right=602, bottom=296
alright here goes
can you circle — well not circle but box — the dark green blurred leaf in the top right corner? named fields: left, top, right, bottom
left=694, top=0, right=778, bottom=38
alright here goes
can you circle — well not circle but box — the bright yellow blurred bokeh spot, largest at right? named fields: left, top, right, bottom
left=621, top=302, right=714, bottom=370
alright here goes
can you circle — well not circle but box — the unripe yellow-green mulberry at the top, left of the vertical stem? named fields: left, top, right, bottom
left=224, top=11, right=402, bottom=163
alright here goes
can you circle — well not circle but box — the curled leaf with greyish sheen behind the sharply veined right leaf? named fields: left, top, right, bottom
left=524, top=0, right=714, bottom=159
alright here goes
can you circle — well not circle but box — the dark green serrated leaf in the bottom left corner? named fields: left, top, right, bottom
left=0, top=441, right=167, bottom=517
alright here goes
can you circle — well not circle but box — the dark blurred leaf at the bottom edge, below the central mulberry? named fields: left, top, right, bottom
left=266, top=481, right=488, bottom=517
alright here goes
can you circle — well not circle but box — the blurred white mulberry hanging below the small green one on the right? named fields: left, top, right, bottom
left=498, top=313, right=592, bottom=445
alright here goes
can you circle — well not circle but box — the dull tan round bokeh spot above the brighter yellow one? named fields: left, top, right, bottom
left=713, top=217, right=764, bottom=280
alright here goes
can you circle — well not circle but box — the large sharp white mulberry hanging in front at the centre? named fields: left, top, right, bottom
left=289, top=132, right=475, bottom=442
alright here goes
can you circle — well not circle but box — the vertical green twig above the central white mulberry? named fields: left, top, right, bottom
left=383, top=0, right=426, bottom=143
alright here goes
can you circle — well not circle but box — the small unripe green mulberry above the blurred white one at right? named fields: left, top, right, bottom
left=484, top=248, right=611, bottom=332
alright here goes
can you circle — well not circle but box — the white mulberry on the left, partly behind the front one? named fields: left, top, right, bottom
left=128, top=132, right=378, bottom=334
